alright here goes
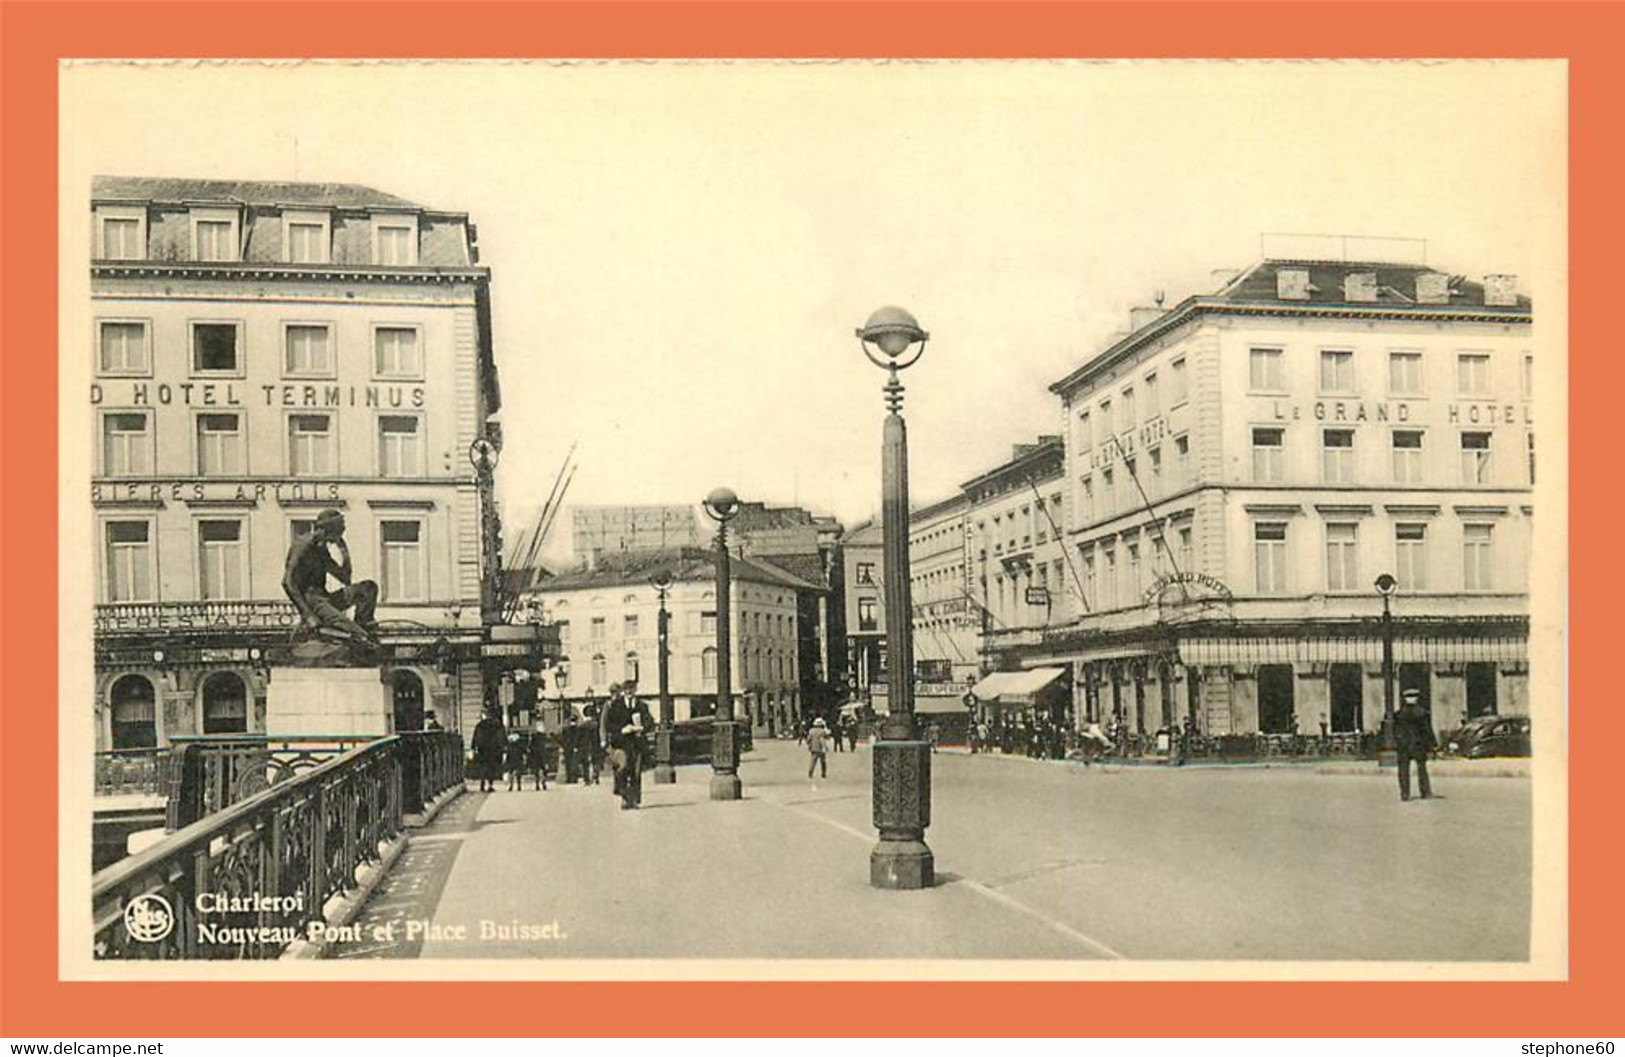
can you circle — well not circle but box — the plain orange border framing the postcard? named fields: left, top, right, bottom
left=0, top=2, right=1625, bottom=1037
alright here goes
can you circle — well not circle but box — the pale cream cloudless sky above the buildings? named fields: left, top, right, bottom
left=62, top=62, right=1567, bottom=561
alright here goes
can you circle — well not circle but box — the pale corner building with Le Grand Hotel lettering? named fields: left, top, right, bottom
left=990, top=260, right=1536, bottom=735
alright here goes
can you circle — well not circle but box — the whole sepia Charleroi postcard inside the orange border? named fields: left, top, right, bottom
left=59, top=59, right=1568, bottom=981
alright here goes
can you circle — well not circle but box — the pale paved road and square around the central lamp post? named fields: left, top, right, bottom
left=326, top=743, right=1531, bottom=961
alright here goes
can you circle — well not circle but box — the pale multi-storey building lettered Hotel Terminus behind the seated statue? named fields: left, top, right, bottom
left=86, top=177, right=501, bottom=748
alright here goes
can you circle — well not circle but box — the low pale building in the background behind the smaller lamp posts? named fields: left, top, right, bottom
left=531, top=548, right=819, bottom=730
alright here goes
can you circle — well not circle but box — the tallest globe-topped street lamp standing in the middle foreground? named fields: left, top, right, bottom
left=858, top=307, right=936, bottom=888
